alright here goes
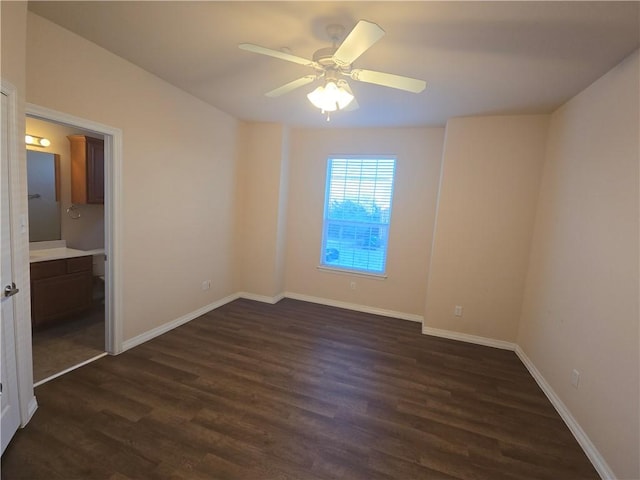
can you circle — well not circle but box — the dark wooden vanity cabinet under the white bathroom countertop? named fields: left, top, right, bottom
left=31, top=255, right=93, bottom=328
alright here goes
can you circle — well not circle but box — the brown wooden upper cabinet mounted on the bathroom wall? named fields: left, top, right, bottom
left=67, top=135, right=104, bottom=204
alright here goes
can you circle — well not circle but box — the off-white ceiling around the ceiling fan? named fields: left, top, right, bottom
left=29, top=1, right=640, bottom=127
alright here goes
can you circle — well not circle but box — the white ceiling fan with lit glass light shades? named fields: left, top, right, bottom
left=238, top=20, right=426, bottom=121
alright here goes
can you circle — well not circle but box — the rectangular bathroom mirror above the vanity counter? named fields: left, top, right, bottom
left=27, top=150, right=61, bottom=242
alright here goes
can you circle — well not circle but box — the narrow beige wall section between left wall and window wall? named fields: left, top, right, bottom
left=237, top=123, right=288, bottom=298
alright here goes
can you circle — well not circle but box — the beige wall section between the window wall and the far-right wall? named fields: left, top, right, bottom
left=424, top=115, right=548, bottom=342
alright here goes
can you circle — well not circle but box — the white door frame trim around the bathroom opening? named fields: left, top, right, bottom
left=25, top=103, right=122, bottom=355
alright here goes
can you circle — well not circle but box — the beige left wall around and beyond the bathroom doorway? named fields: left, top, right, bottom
left=27, top=13, right=237, bottom=340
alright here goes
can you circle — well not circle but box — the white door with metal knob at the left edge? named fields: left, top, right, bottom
left=0, top=93, right=20, bottom=452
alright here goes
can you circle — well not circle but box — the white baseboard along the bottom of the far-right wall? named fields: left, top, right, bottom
left=515, top=345, right=616, bottom=480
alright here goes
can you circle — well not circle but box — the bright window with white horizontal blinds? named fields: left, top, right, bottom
left=321, top=156, right=396, bottom=274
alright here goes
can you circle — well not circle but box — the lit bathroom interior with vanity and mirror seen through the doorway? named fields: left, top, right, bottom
left=26, top=117, right=105, bottom=385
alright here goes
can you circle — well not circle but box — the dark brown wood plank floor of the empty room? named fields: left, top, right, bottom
left=2, top=299, right=599, bottom=480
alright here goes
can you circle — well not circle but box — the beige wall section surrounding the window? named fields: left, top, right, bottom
left=286, top=128, right=444, bottom=317
